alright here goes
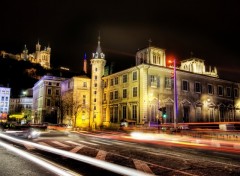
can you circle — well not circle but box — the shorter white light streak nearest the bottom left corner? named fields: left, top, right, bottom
left=0, top=141, right=78, bottom=176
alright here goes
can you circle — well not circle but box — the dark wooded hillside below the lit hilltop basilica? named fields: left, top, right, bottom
left=0, top=57, right=80, bottom=98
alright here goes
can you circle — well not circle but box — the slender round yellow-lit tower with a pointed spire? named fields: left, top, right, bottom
left=90, top=36, right=106, bottom=129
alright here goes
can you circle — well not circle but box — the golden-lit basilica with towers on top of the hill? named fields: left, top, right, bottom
left=0, top=42, right=51, bottom=69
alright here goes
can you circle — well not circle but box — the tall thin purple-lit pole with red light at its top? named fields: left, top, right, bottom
left=173, top=59, right=178, bottom=129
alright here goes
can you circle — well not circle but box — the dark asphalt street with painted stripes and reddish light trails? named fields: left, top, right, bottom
left=0, top=131, right=240, bottom=176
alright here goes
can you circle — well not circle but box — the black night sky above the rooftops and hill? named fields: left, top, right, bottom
left=0, top=0, right=240, bottom=81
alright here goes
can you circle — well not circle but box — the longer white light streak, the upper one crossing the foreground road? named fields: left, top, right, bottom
left=0, top=133, right=152, bottom=176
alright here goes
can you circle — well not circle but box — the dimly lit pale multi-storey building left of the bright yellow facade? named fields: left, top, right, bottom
left=32, top=75, right=65, bottom=123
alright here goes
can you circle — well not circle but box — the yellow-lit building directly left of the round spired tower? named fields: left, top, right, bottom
left=61, top=75, right=93, bottom=128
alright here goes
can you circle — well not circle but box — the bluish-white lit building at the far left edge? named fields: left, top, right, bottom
left=0, top=87, right=11, bottom=121
